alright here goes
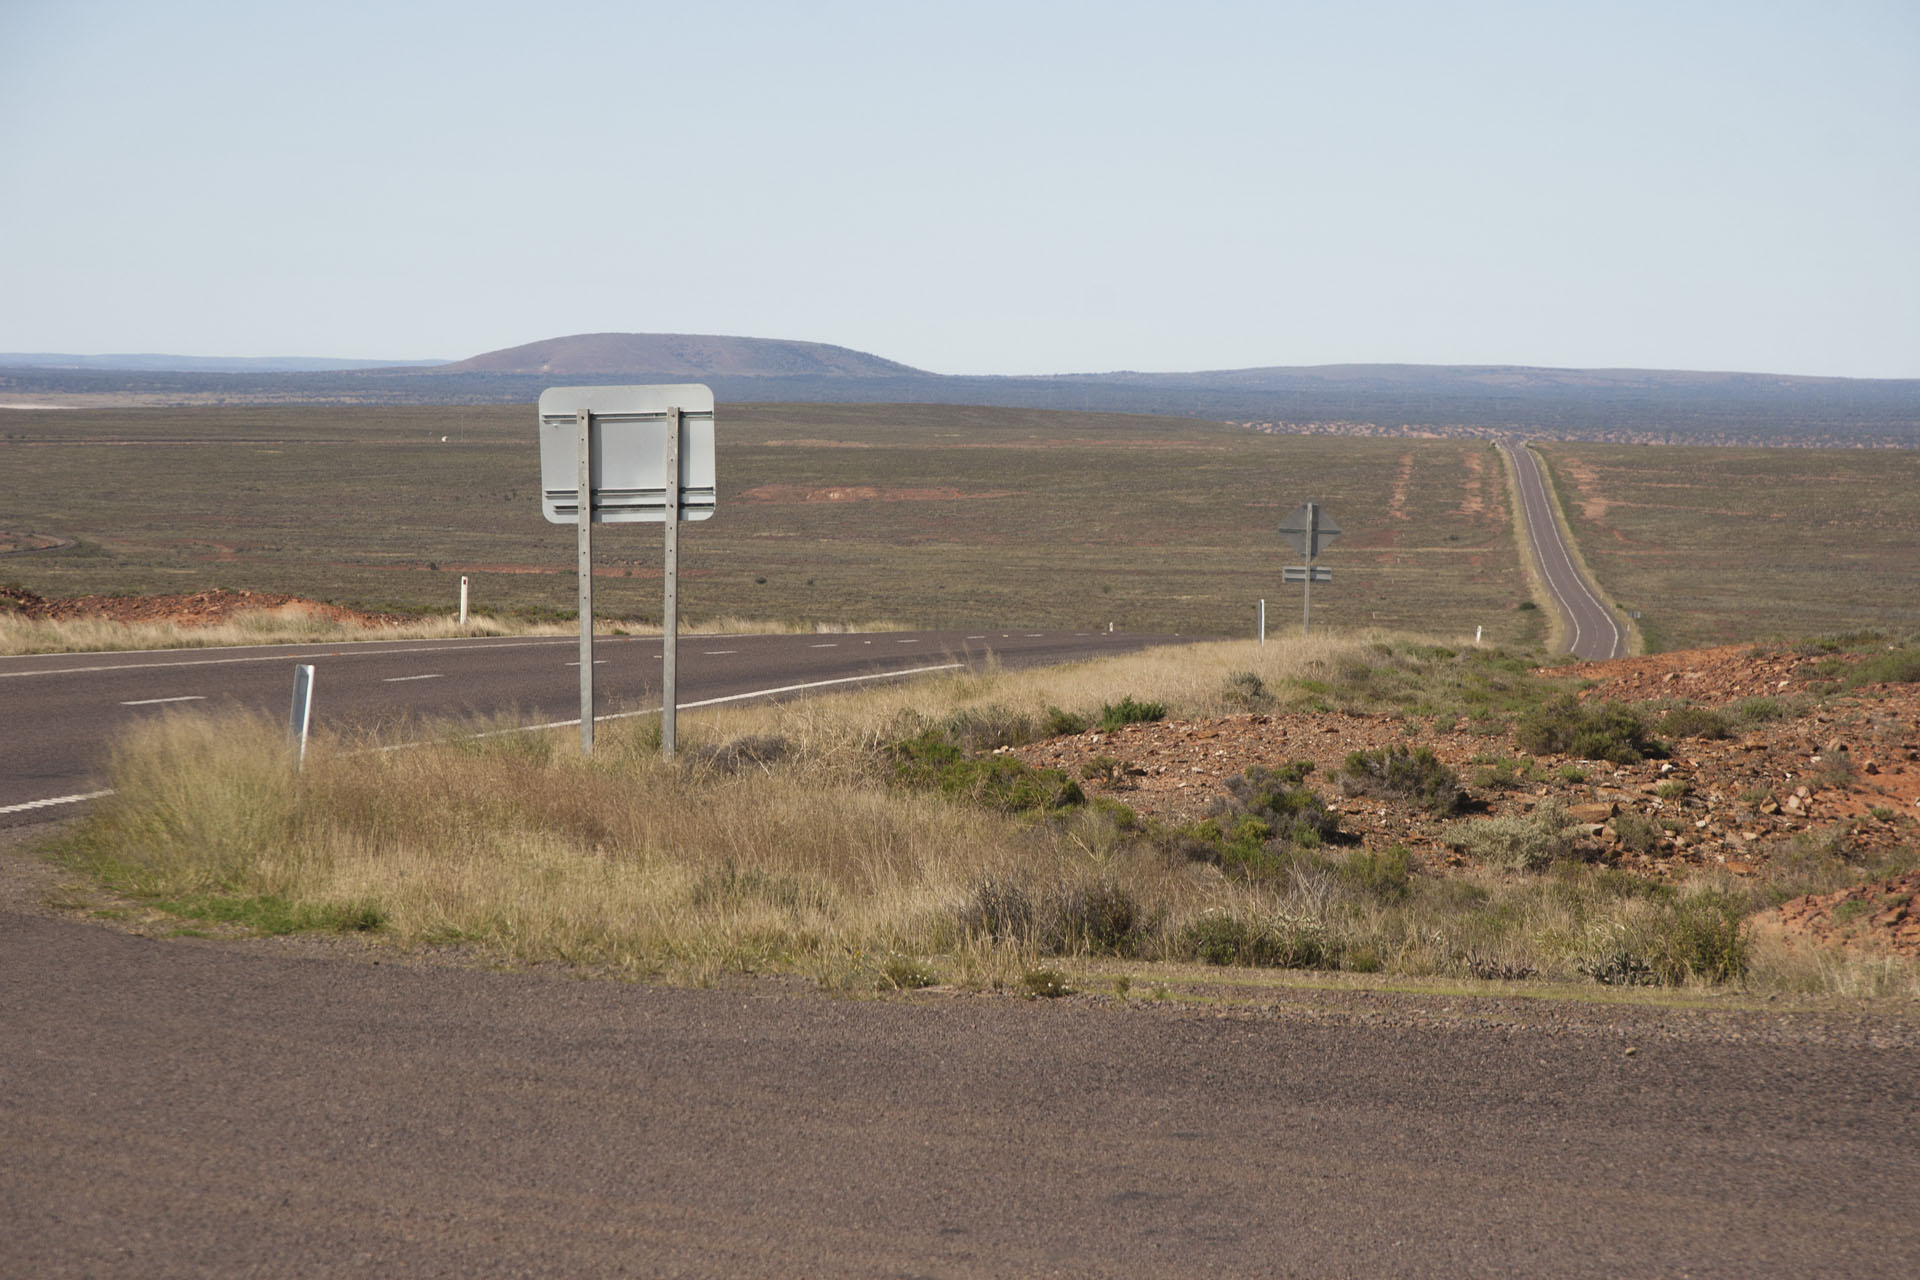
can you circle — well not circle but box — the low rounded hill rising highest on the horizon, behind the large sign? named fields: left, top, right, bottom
left=434, top=334, right=931, bottom=378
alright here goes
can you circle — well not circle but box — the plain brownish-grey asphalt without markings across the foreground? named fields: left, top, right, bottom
left=0, top=913, right=1920, bottom=1276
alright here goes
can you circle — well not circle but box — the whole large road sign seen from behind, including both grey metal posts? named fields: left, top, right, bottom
left=540, top=384, right=718, bottom=756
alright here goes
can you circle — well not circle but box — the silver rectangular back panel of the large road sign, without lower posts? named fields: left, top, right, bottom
left=540, top=382, right=714, bottom=524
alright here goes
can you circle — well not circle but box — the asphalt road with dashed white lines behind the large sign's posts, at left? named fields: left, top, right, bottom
left=0, top=629, right=1181, bottom=825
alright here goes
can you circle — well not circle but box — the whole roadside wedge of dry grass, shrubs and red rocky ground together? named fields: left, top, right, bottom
left=48, top=635, right=1920, bottom=994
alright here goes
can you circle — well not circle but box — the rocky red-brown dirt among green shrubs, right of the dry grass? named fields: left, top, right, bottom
left=1014, top=647, right=1920, bottom=954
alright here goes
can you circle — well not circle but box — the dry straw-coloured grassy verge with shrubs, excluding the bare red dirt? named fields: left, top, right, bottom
left=48, top=637, right=1916, bottom=996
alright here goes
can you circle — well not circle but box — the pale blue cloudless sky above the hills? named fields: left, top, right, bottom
left=0, top=0, right=1920, bottom=378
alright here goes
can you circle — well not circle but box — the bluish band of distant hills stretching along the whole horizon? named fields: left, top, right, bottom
left=0, top=334, right=1920, bottom=449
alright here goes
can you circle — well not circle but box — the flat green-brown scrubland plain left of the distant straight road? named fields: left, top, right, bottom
left=0, top=405, right=1540, bottom=643
